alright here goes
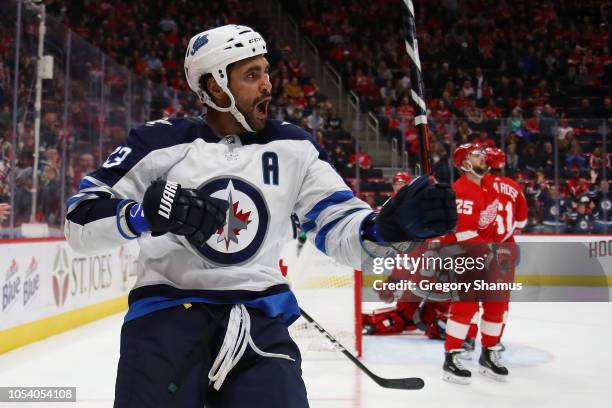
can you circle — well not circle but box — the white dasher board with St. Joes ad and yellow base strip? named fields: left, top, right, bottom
left=0, top=239, right=139, bottom=354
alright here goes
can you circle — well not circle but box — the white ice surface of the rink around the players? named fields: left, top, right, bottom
left=0, top=303, right=612, bottom=408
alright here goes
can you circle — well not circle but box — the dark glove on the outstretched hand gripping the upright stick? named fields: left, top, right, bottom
left=376, top=176, right=457, bottom=242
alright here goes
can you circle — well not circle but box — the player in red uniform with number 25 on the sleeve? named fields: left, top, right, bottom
left=442, top=144, right=508, bottom=384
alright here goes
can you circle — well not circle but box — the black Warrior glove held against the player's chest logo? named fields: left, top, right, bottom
left=142, top=180, right=229, bottom=248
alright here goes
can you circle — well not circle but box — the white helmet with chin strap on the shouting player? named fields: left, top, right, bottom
left=185, top=24, right=267, bottom=132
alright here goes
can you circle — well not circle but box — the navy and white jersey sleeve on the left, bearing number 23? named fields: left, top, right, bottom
left=64, top=116, right=197, bottom=253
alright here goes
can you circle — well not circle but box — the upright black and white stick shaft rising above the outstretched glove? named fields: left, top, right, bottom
left=401, top=0, right=431, bottom=174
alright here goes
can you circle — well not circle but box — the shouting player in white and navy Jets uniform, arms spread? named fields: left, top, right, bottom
left=65, top=25, right=456, bottom=408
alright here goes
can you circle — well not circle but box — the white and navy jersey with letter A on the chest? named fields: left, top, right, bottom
left=65, top=118, right=371, bottom=322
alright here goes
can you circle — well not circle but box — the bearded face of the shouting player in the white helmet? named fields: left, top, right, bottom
left=229, top=56, right=272, bottom=130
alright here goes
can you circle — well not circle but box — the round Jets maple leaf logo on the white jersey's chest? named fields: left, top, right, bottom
left=193, top=177, right=270, bottom=265
